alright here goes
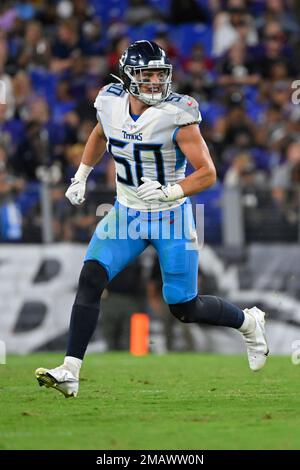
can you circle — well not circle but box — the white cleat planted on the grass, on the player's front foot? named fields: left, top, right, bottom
left=35, top=365, right=79, bottom=398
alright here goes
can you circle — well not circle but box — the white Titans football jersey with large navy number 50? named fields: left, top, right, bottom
left=94, top=83, right=201, bottom=211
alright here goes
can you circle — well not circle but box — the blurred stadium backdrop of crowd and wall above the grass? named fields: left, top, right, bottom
left=0, top=0, right=300, bottom=354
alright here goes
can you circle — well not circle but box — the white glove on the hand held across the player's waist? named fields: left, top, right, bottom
left=137, top=177, right=184, bottom=202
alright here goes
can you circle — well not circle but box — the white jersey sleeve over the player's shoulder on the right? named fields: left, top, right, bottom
left=165, top=93, right=202, bottom=126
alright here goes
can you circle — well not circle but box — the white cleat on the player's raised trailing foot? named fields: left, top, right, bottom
left=242, top=307, right=269, bottom=371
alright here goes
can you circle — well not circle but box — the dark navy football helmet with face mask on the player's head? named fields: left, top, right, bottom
left=119, top=41, right=172, bottom=106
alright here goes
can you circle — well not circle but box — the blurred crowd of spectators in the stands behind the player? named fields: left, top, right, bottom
left=0, top=0, right=300, bottom=242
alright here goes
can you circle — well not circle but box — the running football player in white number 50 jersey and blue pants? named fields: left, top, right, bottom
left=36, top=41, right=268, bottom=397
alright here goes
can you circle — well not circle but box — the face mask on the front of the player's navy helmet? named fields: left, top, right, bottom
left=124, top=64, right=172, bottom=106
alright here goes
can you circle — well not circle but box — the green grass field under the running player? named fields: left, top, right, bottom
left=0, top=353, right=300, bottom=450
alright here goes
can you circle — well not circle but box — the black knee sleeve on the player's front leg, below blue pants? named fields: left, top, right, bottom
left=75, top=260, right=108, bottom=307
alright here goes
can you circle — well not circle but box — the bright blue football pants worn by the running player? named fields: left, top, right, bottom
left=84, top=199, right=198, bottom=304
